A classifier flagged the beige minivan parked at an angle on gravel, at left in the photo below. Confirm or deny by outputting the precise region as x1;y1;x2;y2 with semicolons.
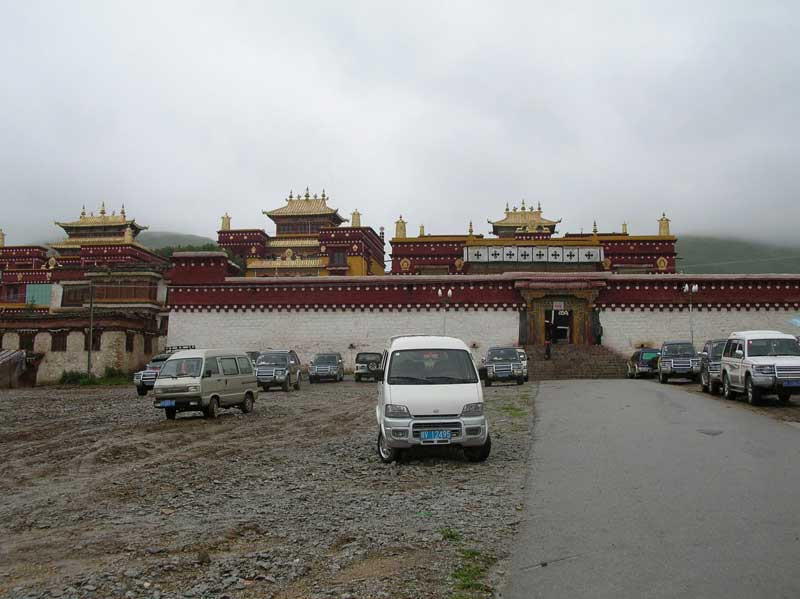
153;349;258;420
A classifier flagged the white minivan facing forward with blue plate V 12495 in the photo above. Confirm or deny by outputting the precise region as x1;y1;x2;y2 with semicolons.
375;335;492;463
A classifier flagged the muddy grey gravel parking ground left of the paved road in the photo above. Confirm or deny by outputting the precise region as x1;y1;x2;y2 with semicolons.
0;382;537;599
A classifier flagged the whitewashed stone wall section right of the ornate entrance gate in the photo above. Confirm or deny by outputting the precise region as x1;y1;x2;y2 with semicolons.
600;310;800;354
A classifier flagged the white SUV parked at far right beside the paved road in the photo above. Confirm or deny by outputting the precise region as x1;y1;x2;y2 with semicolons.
722;331;800;405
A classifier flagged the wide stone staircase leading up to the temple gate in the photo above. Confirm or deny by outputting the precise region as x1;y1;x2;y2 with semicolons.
525;344;627;381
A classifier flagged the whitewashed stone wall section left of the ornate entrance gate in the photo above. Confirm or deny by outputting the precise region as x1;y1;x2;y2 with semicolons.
167;310;519;368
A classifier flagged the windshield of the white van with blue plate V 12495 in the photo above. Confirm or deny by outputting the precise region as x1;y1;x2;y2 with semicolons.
387;349;478;385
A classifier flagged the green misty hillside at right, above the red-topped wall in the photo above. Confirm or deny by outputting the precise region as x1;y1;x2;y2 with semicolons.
677;235;800;274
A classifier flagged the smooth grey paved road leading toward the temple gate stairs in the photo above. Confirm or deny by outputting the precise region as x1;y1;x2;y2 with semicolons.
502;380;800;599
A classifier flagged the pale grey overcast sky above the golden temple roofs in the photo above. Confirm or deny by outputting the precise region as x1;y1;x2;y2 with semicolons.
0;0;800;244
